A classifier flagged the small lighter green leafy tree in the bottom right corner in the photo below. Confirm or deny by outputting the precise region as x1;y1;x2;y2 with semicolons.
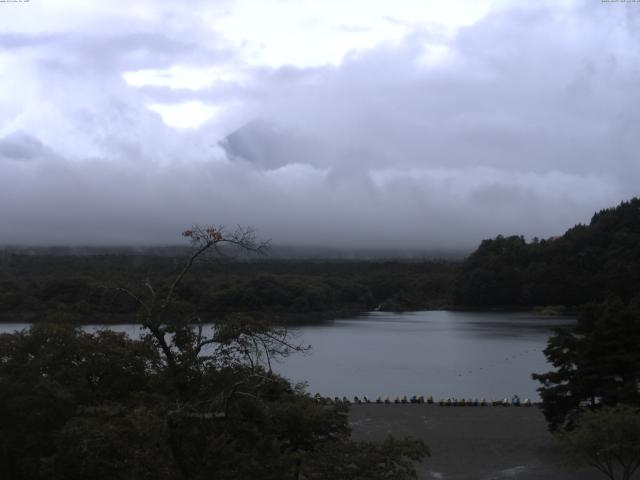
557;406;640;480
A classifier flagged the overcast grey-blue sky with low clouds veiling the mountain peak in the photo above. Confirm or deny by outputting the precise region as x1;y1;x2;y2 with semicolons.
0;0;640;248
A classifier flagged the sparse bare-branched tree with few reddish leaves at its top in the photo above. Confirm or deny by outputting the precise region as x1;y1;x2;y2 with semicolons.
116;225;308;394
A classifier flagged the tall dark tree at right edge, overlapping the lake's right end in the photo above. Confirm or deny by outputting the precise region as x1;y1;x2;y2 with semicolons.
533;297;640;430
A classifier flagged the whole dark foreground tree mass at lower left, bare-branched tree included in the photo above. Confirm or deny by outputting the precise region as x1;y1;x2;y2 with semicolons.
0;228;429;480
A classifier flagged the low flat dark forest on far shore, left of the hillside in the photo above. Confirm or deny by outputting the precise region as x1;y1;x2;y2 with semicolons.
0;252;456;322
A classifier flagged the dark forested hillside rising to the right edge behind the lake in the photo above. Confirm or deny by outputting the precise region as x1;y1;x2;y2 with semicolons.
453;198;640;307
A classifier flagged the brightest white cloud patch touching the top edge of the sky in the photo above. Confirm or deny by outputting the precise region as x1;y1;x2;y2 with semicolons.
212;0;497;67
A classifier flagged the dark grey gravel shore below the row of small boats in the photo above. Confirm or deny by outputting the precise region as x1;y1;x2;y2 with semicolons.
349;404;604;480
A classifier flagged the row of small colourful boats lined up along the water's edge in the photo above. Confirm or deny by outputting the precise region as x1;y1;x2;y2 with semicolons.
314;393;533;407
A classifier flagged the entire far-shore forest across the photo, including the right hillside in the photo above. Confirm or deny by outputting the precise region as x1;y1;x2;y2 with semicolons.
0;198;640;323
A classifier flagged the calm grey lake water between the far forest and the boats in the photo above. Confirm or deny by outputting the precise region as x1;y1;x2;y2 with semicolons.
0;311;571;399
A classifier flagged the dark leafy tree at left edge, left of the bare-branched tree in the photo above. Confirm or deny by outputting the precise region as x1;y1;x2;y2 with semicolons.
0;324;158;480
